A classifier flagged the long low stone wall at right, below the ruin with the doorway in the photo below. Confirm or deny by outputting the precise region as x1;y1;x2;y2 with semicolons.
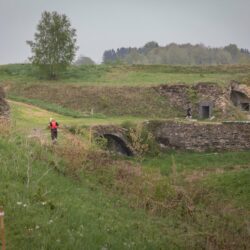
148;121;250;151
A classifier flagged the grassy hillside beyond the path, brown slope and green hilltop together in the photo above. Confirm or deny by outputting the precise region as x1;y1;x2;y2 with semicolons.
0;64;250;119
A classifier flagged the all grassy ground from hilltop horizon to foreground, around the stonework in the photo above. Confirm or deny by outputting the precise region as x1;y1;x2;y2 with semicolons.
0;65;250;250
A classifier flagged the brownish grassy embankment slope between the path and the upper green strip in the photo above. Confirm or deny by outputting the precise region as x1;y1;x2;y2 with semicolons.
7;83;180;118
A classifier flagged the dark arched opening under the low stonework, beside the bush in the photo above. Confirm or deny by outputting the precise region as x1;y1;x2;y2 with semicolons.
103;134;134;156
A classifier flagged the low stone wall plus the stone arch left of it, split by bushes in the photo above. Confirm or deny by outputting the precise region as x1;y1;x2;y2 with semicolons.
92;120;250;156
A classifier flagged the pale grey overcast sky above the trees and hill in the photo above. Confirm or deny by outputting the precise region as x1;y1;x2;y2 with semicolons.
0;0;250;64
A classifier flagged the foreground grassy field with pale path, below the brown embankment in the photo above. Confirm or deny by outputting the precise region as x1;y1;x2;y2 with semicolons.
0;99;250;250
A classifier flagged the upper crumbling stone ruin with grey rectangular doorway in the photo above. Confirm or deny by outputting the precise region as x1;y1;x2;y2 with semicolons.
154;81;250;119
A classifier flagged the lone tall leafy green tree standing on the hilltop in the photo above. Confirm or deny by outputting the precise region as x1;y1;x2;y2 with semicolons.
27;11;77;79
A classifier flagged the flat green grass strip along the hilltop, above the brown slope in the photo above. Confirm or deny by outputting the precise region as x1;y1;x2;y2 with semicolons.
0;64;250;86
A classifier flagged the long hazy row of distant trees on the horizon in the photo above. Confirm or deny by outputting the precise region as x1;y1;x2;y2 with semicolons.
103;41;250;65
